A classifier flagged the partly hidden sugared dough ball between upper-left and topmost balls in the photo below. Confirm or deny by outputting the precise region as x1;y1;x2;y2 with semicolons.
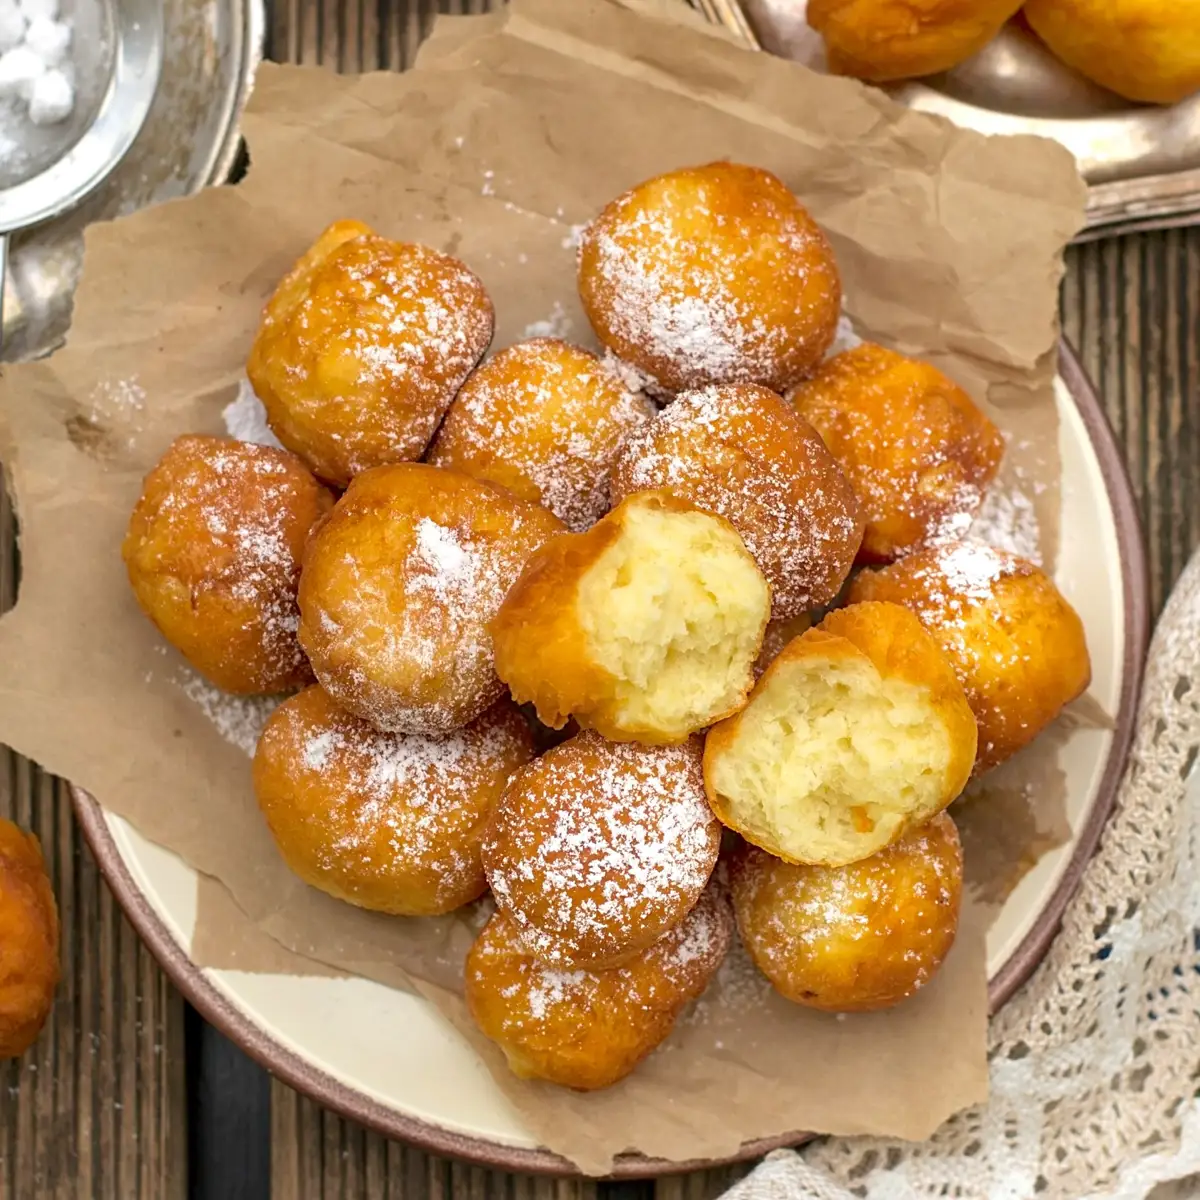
428;337;655;530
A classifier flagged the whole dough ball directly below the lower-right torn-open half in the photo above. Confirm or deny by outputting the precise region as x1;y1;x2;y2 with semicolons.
730;812;962;1013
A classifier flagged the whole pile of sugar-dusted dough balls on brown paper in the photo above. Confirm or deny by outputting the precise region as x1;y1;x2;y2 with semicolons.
124;163;1087;1090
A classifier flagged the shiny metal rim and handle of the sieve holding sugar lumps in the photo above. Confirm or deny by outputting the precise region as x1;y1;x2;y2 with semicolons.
0;0;163;350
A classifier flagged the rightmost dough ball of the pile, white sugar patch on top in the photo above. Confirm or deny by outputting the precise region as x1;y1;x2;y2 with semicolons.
850;540;1092;775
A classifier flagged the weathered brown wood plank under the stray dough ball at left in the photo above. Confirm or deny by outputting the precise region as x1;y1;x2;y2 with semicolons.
0;472;186;1200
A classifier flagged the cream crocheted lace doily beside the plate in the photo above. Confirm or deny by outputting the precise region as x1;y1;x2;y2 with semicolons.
728;554;1200;1200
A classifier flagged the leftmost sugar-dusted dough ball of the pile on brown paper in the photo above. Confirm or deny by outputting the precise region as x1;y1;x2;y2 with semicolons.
121;436;334;695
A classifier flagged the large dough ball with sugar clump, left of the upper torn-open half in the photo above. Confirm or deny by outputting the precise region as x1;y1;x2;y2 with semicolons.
300;463;563;736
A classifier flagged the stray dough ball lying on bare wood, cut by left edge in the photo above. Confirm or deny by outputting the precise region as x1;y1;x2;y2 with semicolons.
0;820;61;1058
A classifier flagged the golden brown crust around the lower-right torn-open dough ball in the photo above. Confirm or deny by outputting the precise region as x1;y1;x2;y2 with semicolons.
704;602;978;865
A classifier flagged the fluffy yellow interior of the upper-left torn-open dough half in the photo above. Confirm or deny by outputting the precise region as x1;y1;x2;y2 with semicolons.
578;506;770;738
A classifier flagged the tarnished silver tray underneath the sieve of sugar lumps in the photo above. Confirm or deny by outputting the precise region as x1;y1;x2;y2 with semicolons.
4;0;264;361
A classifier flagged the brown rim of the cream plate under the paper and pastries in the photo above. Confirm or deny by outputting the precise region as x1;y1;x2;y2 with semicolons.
71;342;1150;1178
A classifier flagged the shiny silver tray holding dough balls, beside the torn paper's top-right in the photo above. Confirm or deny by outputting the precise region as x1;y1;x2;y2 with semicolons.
697;0;1200;238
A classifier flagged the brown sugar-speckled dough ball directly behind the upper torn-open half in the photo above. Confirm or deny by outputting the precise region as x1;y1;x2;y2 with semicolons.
612;384;863;620
